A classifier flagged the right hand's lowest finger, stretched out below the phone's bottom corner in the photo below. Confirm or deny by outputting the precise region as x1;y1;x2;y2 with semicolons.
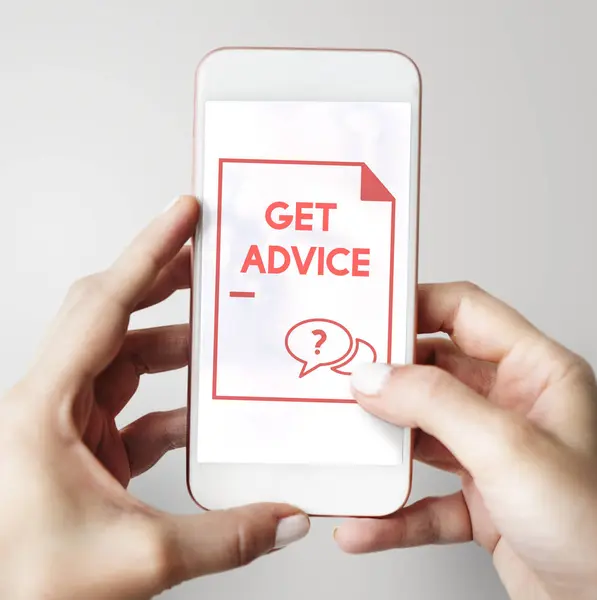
334;492;472;554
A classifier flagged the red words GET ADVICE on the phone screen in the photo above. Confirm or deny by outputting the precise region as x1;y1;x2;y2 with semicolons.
240;202;371;277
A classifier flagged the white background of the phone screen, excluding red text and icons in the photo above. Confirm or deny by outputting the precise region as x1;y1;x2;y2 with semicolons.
198;102;410;465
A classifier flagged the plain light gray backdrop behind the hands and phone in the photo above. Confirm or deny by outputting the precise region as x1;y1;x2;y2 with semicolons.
0;0;597;600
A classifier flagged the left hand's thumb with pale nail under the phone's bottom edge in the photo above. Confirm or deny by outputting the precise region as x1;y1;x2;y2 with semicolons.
151;504;310;589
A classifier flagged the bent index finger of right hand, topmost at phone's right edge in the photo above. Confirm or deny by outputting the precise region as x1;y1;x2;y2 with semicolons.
418;283;543;362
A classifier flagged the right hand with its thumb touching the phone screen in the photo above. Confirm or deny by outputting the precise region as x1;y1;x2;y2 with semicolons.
335;284;597;600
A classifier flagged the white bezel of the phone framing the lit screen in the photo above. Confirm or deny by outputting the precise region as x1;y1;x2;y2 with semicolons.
187;48;421;517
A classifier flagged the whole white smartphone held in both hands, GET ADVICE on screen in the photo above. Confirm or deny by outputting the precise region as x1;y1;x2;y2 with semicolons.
188;48;421;516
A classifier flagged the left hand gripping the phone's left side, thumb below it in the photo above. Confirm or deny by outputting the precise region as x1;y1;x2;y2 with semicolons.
0;197;309;600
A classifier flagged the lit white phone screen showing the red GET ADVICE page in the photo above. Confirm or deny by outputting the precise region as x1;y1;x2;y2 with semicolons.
194;101;412;466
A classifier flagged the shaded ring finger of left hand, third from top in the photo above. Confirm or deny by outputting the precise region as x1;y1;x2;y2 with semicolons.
94;325;189;417
